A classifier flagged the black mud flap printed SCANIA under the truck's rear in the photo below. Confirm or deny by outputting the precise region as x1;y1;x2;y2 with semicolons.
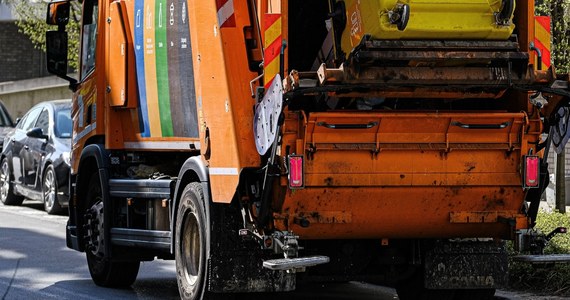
424;241;508;289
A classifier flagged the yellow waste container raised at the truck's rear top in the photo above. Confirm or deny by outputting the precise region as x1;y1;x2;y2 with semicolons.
342;0;515;53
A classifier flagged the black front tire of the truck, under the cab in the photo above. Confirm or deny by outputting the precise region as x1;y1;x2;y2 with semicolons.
85;174;140;287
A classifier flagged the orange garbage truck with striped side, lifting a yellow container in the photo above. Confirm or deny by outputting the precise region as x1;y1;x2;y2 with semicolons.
46;0;570;299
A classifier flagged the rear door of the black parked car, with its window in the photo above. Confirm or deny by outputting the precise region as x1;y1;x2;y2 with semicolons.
8;107;42;185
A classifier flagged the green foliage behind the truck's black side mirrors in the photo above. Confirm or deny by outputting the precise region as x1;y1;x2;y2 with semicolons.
6;0;81;69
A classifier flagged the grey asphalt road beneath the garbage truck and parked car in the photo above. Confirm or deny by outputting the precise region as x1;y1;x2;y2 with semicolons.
0;201;556;300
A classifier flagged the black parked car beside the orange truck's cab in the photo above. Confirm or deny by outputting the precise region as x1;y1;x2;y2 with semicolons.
0;100;72;214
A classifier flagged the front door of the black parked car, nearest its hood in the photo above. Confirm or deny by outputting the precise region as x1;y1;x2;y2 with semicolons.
24;106;51;191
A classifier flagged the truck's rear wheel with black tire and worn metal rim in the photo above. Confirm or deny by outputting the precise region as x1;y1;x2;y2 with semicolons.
175;182;209;300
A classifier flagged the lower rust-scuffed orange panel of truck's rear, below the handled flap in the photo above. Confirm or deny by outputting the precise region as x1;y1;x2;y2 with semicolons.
276;188;528;239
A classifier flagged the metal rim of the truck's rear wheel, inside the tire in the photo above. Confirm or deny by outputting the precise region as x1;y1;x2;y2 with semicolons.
180;213;202;285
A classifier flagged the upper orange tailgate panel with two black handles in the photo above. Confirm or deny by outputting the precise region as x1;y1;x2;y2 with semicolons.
305;112;526;152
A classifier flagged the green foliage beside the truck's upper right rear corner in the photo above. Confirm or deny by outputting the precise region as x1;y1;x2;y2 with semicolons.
536;0;570;73
